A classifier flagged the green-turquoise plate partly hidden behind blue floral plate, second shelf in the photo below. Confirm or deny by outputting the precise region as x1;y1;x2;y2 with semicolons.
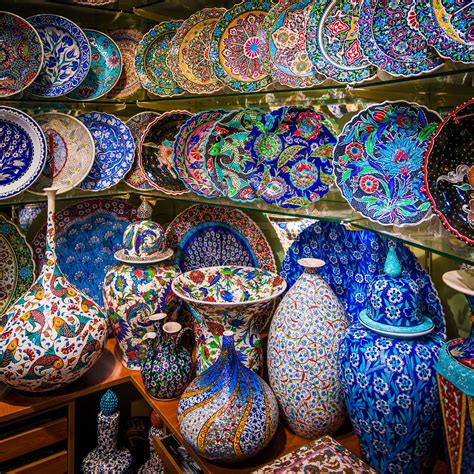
204;108;263;202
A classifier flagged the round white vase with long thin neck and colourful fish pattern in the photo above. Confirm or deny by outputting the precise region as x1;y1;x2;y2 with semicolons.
0;188;107;392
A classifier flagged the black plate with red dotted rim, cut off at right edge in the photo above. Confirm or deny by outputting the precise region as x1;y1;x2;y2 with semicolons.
424;99;474;245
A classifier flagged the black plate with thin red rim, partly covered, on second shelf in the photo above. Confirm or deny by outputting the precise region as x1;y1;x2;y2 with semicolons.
139;110;192;195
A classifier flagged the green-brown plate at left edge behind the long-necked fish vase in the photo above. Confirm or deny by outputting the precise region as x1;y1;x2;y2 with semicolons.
0;214;35;318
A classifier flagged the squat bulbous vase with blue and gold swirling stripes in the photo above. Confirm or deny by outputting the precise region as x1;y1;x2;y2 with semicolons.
178;331;278;462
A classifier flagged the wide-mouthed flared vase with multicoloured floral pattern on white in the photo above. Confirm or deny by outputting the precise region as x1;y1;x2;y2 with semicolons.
172;266;286;374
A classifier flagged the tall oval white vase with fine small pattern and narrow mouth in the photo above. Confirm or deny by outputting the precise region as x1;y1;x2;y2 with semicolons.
268;258;347;438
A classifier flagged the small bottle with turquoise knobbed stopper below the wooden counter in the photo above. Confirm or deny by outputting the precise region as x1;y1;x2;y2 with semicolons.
81;390;132;474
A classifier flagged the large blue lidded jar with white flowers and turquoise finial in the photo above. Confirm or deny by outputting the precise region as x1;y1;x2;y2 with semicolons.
339;247;444;473
